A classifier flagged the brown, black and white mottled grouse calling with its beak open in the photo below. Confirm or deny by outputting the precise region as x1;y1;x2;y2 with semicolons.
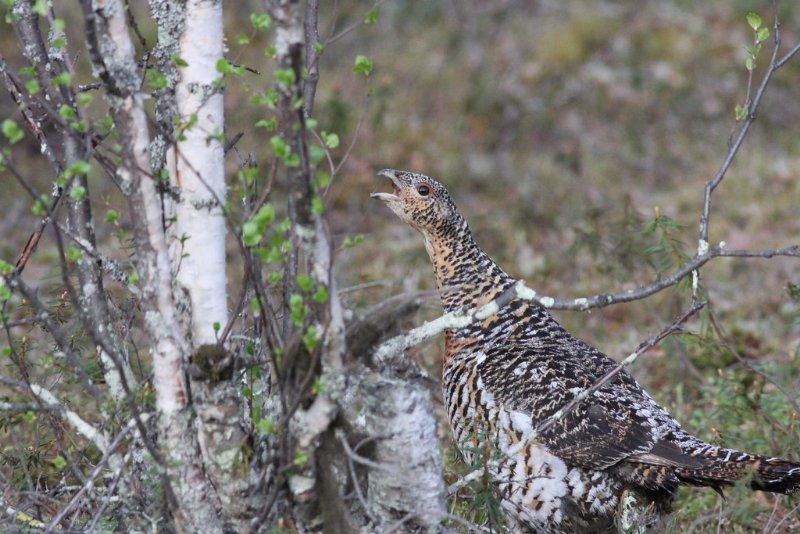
372;169;800;532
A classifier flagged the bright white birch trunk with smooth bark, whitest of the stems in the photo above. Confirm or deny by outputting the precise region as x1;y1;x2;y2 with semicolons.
167;0;228;346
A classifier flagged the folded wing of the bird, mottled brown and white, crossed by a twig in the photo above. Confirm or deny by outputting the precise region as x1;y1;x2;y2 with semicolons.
478;338;659;469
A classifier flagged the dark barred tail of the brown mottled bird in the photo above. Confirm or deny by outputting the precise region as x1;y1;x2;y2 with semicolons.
676;448;800;495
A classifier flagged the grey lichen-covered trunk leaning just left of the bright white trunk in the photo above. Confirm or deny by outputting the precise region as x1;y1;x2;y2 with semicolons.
82;0;222;531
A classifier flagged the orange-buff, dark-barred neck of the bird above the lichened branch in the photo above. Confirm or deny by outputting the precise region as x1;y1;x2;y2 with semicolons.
423;221;515;312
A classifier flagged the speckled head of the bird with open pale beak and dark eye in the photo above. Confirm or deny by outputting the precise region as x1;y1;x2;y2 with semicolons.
370;169;465;236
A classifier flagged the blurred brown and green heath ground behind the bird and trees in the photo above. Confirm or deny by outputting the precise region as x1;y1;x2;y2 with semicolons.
0;0;800;531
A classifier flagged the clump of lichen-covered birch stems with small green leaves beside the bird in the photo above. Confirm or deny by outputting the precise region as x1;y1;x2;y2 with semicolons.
2;0;445;532
